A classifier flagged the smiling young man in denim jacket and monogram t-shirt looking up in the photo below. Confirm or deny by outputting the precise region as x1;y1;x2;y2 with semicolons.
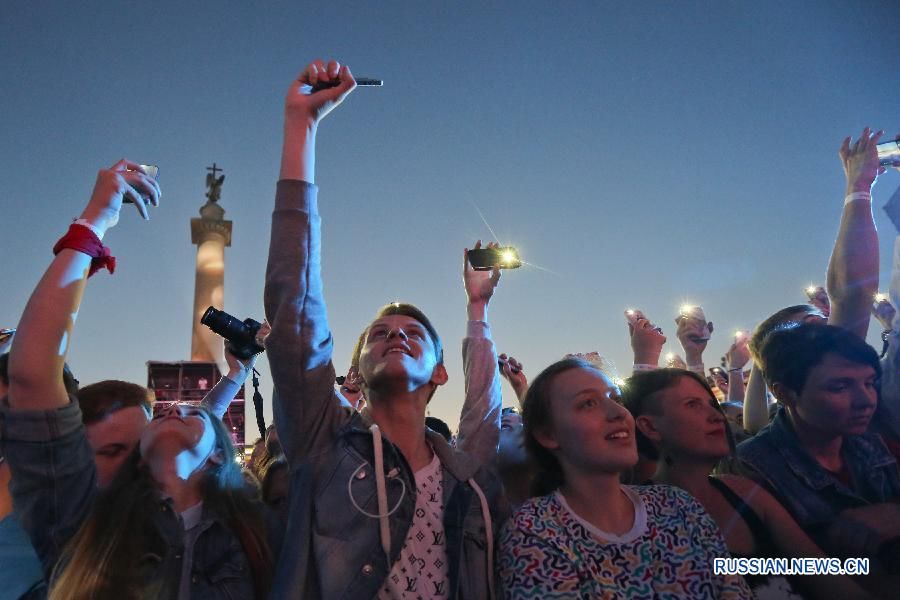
265;61;505;599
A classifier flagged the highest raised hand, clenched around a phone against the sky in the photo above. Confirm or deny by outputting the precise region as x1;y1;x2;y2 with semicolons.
284;60;356;126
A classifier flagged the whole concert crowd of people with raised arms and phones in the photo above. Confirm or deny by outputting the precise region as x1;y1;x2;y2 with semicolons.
0;61;900;600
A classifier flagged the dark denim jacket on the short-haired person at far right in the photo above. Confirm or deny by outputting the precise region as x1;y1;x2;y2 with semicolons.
737;407;900;546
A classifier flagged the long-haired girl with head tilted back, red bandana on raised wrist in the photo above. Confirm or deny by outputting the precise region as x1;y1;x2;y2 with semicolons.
0;160;273;600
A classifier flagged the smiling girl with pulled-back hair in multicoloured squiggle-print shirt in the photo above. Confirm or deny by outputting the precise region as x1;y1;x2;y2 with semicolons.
500;358;752;598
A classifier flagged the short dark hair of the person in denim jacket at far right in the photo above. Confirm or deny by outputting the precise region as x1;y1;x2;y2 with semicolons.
759;324;881;394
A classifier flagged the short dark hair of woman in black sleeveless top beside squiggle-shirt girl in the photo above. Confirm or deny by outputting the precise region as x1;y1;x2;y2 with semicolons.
622;369;722;460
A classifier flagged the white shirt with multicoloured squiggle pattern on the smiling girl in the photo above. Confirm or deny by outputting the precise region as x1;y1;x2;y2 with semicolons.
500;485;753;600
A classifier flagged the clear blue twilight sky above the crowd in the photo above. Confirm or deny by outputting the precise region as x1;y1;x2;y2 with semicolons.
0;0;900;437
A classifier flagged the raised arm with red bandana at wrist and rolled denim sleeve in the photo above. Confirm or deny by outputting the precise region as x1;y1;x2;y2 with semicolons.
0;160;160;578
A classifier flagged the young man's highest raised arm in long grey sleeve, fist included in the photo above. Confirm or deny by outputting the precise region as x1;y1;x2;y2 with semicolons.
265;61;356;466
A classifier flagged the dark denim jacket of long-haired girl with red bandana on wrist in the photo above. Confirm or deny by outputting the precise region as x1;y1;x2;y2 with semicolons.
0;398;268;600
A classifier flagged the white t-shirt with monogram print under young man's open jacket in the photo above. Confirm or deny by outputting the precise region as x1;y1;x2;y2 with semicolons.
378;454;450;600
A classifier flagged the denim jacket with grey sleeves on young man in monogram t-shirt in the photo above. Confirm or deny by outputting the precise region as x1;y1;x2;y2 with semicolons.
265;181;508;600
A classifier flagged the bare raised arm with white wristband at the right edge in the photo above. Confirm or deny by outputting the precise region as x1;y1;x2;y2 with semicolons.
828;127;884;339
